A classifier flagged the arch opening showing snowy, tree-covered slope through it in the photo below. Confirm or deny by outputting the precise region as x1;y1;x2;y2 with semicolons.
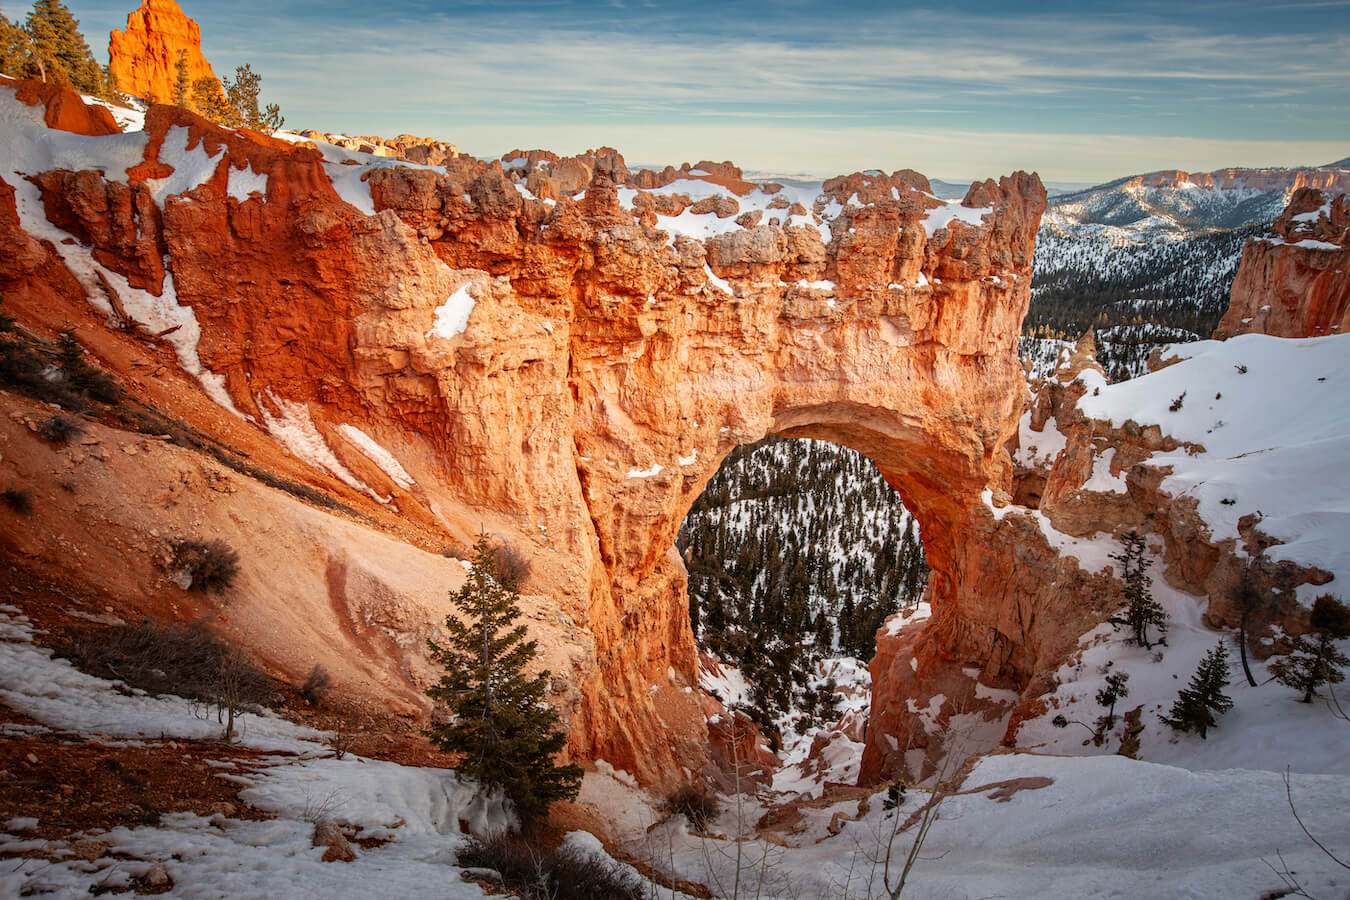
676;434;929;758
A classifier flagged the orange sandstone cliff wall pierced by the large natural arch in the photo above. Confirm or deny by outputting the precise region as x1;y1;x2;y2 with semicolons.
0;84;1047;781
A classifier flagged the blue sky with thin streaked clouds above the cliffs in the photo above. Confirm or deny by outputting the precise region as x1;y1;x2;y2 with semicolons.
10;0;1350;184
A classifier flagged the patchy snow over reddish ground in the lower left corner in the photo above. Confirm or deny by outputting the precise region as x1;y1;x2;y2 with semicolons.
0;606;509;899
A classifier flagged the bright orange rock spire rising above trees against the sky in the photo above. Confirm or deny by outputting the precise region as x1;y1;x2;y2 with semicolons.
108;0;216;103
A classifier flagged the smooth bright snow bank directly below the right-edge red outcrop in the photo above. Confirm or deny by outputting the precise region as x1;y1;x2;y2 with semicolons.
1079;335;1350;603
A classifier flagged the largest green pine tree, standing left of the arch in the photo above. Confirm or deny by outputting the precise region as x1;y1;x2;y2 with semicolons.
425;534;582;826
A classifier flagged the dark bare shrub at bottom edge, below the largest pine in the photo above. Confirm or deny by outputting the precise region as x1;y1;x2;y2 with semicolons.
456;831;651;900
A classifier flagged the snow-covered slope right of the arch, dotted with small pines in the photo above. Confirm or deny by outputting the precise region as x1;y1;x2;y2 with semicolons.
1018;335;1350;776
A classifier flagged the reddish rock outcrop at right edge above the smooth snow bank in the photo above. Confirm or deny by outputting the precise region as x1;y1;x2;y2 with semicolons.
1214;185;1350;340
